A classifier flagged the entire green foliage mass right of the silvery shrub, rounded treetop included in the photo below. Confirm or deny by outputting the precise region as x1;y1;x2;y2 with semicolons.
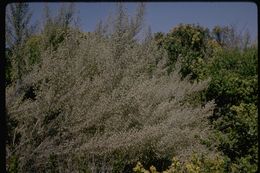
155;25;258;172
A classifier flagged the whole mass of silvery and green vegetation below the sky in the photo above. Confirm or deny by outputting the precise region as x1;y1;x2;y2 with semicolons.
6;3;258;173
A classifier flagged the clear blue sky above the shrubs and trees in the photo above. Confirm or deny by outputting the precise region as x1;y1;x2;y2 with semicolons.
25;2;257;38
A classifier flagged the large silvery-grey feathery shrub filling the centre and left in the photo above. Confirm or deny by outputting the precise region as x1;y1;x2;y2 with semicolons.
7;24;213;172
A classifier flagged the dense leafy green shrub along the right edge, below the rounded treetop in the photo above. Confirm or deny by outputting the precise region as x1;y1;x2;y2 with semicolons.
207;48;258;172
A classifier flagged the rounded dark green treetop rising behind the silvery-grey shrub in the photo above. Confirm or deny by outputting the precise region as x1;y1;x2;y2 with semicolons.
162;24;209;79
